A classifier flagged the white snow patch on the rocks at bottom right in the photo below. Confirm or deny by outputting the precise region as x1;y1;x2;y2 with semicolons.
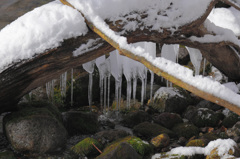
152;139;237;159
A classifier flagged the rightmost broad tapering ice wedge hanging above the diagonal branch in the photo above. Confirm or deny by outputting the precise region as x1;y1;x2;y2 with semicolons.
186;47;202;75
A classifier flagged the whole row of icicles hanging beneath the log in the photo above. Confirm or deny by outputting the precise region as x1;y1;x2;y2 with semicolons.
46;42;206;112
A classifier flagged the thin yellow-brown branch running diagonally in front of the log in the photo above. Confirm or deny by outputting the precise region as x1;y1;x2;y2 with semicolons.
60;0;240;115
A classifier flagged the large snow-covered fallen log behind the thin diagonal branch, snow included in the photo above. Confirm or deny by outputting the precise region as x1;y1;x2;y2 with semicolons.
0;0;240;112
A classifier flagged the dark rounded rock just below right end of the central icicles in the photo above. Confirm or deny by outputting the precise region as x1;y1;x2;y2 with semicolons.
121;111;151;128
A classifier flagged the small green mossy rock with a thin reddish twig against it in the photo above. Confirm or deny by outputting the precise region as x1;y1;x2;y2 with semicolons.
71;137;102;157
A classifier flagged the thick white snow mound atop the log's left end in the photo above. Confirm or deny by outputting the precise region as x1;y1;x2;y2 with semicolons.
0;1;88;72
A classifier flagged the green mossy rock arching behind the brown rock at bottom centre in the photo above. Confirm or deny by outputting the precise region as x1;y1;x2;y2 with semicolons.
99;136;153;156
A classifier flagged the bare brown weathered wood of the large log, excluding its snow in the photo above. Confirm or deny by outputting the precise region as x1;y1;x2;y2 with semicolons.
0;1;240;113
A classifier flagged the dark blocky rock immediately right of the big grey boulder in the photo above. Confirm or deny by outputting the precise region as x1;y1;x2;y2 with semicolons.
63;111;99;135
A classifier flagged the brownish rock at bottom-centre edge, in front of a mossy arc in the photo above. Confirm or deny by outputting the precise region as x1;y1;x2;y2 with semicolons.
96;142;142;159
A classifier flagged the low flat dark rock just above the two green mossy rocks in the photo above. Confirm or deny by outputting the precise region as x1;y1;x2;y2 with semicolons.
95;129;129;144
